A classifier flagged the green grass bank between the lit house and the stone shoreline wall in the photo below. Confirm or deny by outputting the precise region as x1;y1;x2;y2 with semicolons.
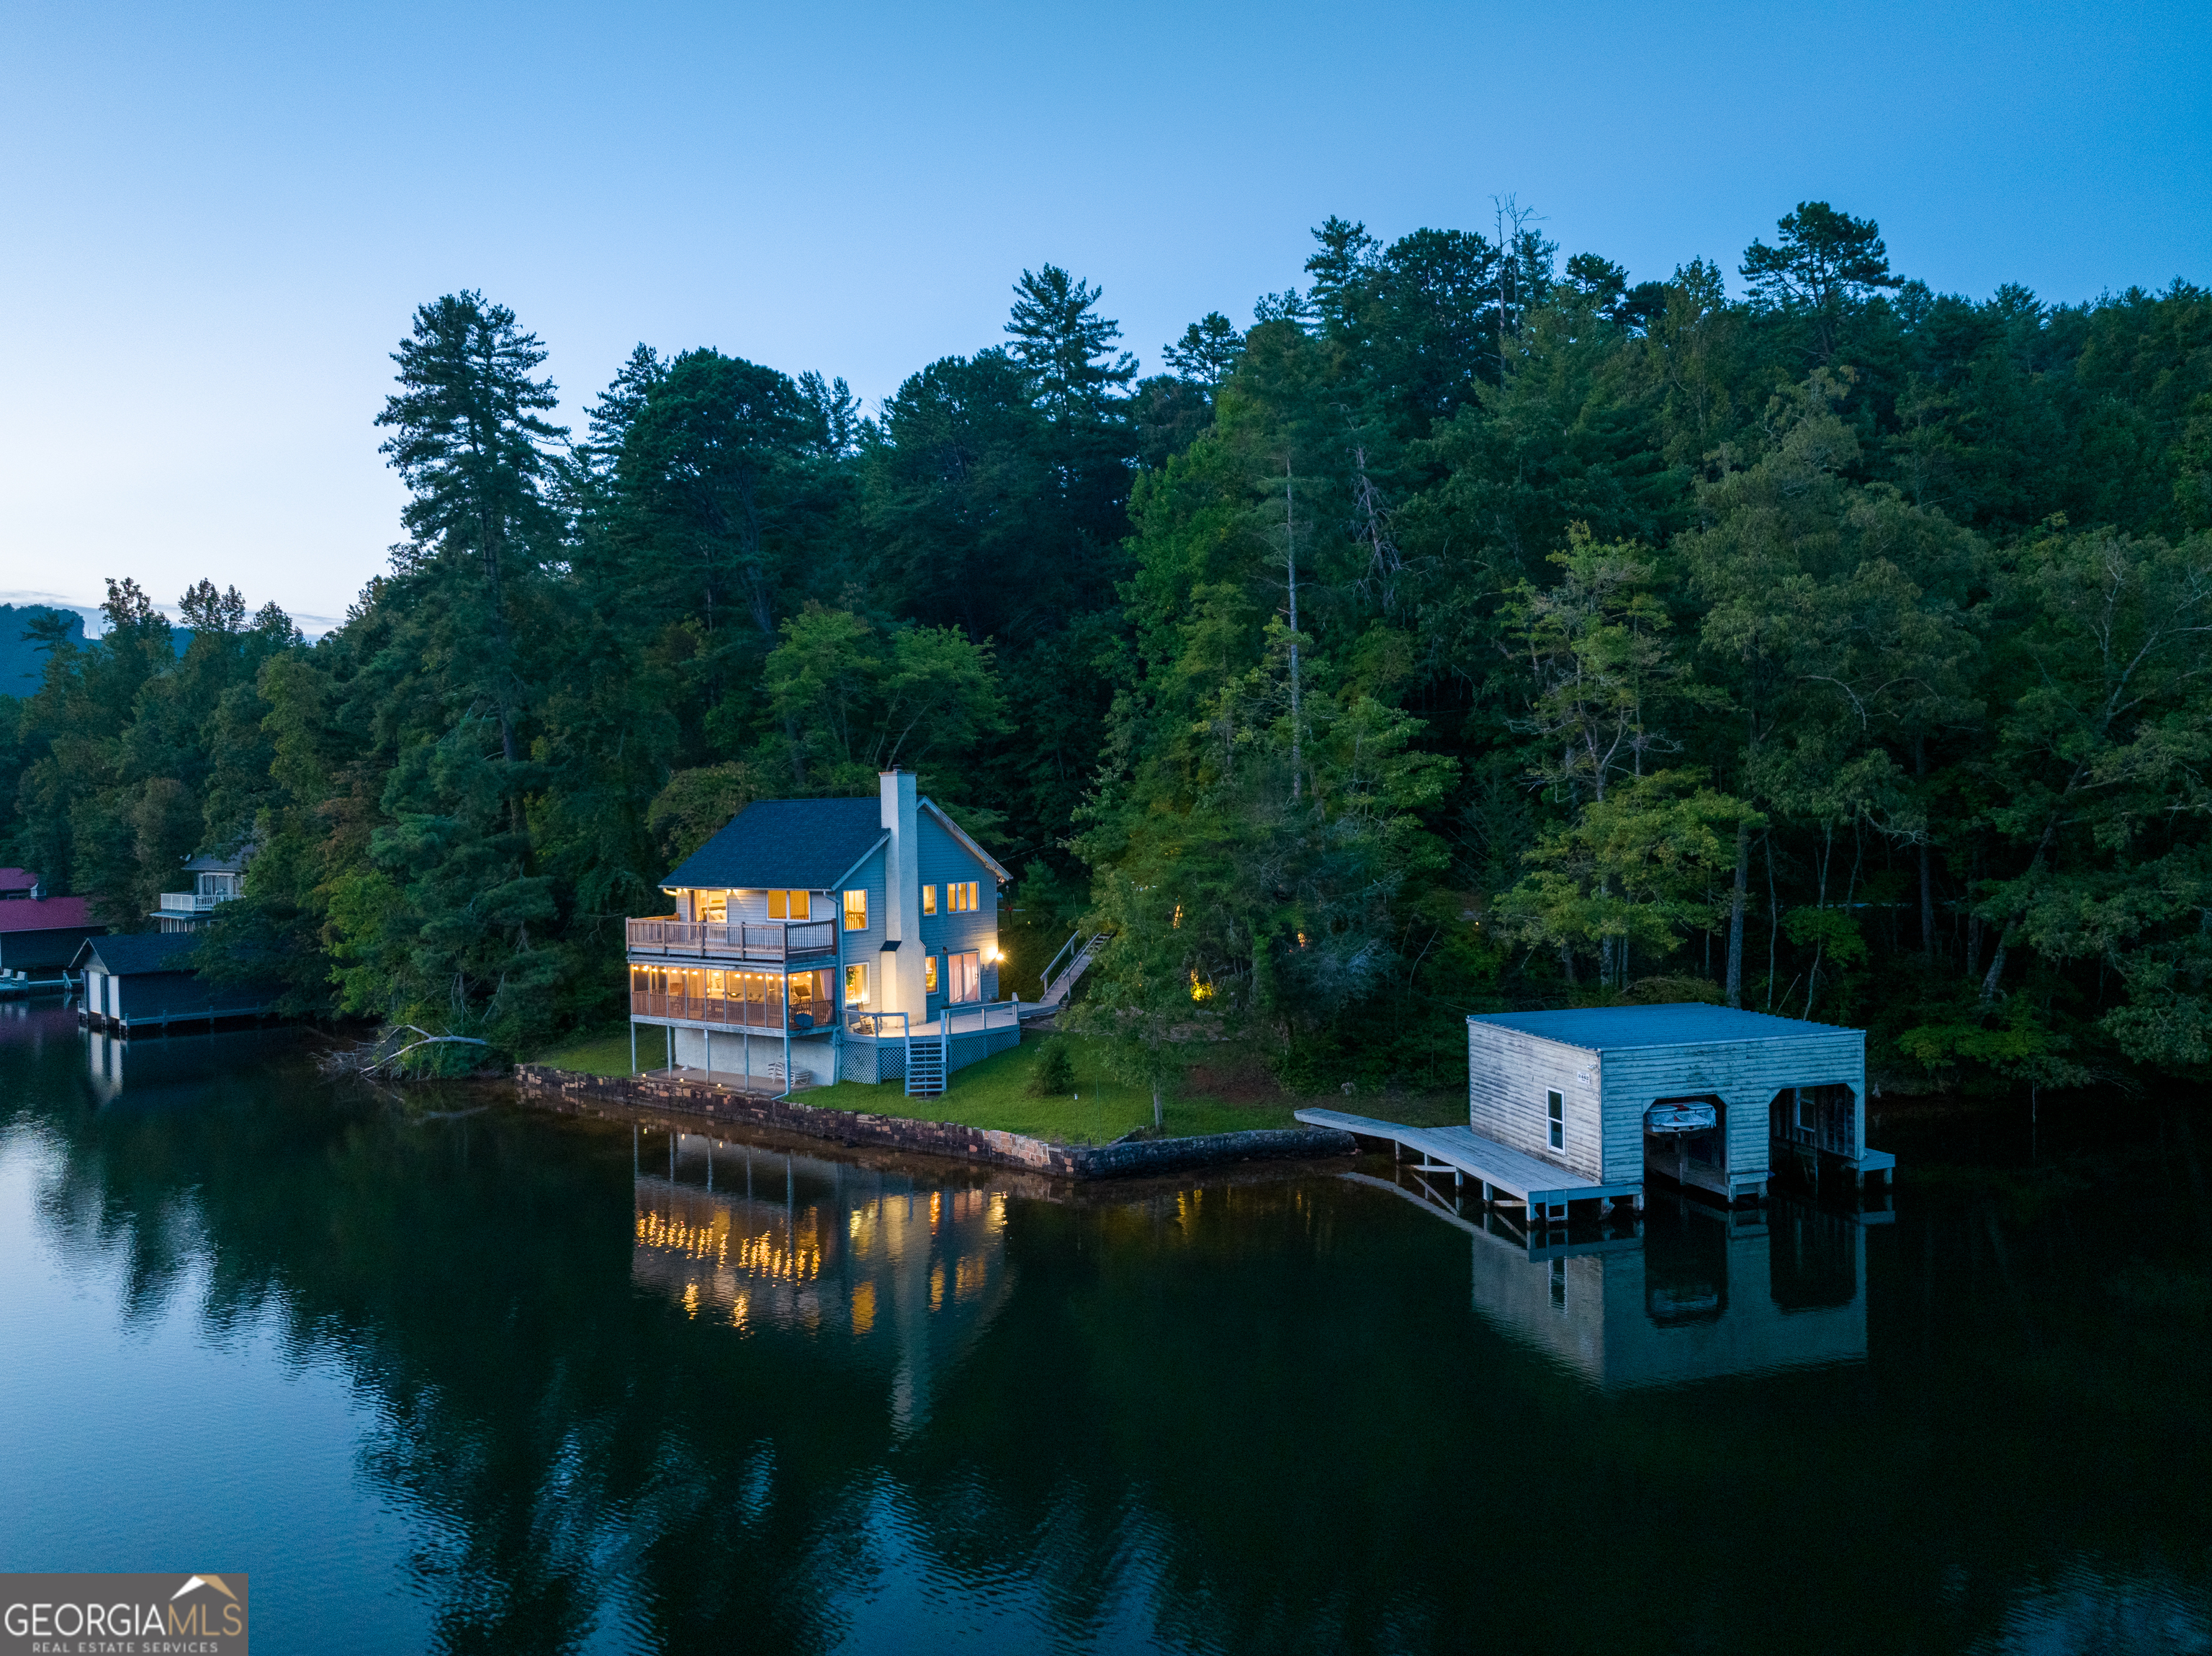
537;1030;1467;1146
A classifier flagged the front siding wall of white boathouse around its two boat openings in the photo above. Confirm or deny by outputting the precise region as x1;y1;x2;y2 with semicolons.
1597;1030;1867;1176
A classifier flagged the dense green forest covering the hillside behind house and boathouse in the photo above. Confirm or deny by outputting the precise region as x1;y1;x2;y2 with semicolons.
0;201;2212;1088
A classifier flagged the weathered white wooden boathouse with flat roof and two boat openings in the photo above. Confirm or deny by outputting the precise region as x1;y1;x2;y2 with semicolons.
1467;1002;1894;1200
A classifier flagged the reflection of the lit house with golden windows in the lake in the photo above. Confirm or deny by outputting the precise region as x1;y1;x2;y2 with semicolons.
631;1128;1011;1431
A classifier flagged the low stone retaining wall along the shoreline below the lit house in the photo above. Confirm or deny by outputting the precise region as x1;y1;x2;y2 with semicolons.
516;1063;1356;1179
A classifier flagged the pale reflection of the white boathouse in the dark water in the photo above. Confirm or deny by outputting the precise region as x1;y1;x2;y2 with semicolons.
1471;1196;1884;1388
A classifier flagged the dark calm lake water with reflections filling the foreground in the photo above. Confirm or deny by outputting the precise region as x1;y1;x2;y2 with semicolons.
0;1002;2212;1656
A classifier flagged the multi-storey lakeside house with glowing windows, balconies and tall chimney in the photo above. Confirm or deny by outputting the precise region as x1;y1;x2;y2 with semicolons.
626;772;1020;1092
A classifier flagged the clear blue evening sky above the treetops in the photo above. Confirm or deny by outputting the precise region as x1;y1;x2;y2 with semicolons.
0;0;2212;617
